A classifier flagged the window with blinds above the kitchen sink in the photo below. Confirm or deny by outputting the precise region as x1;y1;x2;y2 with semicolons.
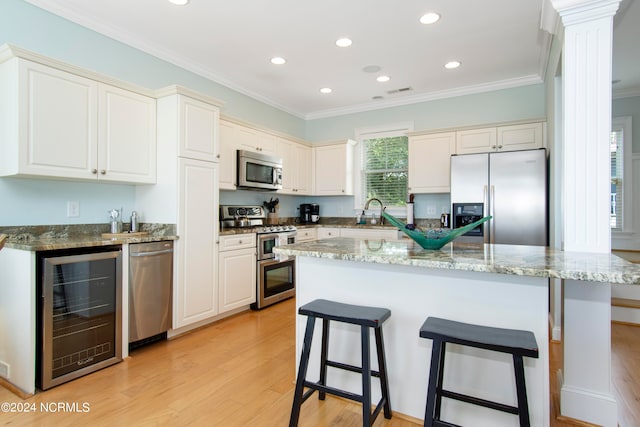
356;126;410;210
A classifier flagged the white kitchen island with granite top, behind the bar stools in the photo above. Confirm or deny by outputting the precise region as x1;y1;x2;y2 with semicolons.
275;238;640;427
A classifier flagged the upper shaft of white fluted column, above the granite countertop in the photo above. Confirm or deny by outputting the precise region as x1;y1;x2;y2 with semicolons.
552;0;620;253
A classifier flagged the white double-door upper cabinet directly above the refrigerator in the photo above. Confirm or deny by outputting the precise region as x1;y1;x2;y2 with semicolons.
456;122;544;154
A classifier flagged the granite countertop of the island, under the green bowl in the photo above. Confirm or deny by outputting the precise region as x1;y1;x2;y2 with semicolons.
274;237;640;285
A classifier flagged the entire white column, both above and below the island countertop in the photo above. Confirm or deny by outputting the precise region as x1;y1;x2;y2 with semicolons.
551;0;620;427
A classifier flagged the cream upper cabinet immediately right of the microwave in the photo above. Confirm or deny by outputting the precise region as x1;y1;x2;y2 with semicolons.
276;138;311;195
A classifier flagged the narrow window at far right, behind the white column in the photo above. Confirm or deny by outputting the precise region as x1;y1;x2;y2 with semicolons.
609;117;631;231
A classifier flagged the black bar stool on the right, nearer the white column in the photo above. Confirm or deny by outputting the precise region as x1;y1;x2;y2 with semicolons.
420;317;538;427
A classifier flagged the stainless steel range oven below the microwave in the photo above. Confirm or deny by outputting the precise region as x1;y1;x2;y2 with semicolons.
252;231;296;309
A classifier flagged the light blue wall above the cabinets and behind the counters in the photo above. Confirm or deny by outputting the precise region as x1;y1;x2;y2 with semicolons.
0;0;544;225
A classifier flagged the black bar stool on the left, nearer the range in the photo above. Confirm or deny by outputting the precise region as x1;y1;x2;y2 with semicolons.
289;299;391;427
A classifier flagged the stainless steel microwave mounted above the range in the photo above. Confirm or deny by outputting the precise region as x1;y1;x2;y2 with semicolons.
237;150;282;190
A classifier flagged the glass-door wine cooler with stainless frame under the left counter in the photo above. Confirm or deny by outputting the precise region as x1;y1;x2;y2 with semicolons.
37;246;122;390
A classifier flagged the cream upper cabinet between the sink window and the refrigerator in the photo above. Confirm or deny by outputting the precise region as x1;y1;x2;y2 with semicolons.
407;132;456;193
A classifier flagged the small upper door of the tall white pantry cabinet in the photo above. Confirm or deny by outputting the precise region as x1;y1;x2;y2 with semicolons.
177;95;220;162
